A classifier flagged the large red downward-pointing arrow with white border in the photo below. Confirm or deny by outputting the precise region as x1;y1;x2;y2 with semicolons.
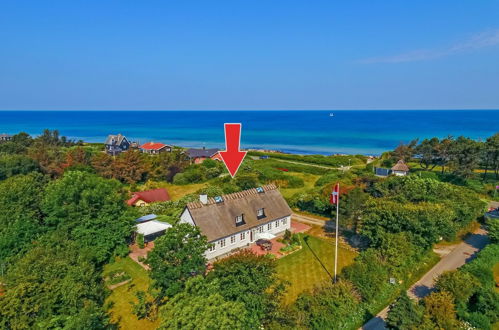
220;124;246;177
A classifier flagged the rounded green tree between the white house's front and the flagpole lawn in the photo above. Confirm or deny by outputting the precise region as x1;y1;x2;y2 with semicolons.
208;250;284;326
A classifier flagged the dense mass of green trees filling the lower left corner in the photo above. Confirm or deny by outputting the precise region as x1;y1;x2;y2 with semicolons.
0;171;135;329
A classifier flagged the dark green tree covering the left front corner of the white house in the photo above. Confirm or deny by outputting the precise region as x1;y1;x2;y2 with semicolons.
146;223;209;301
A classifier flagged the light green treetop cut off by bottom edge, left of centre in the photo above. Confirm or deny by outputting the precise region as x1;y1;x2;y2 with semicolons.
160;276;250;330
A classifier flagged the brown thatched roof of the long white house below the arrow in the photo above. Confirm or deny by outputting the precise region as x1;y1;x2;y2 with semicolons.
187;184;291;241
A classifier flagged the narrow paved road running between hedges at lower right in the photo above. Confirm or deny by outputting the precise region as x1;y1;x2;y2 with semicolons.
361;228;489;330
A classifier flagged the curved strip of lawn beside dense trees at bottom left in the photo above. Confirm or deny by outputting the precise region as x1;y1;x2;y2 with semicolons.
104;257;159;330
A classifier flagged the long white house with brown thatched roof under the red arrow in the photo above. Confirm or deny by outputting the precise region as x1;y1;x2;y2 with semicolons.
180;185;291;260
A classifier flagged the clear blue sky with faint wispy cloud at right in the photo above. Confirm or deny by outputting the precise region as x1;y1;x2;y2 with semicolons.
0;0;499;110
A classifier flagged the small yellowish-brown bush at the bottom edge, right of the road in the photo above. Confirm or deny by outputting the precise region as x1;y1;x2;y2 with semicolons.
423;291;457;329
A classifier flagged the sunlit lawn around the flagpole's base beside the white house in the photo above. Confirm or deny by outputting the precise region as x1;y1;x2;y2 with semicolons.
277;235;357;304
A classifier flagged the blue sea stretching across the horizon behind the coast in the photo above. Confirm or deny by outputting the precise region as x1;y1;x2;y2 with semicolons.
0;110;499;155
